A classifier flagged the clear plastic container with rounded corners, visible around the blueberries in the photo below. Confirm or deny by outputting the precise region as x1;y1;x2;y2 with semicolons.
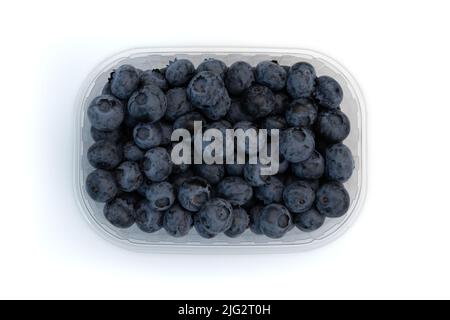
74;48;367;253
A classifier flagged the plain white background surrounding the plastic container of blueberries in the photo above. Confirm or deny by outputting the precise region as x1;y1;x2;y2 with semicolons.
0;0;450;299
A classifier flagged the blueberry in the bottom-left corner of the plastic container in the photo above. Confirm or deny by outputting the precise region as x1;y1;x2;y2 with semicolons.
103;195;135;229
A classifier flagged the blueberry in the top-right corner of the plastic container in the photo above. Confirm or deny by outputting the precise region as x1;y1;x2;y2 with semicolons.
313;76;344;109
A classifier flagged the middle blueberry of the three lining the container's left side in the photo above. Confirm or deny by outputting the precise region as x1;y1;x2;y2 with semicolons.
87;140;122;170
